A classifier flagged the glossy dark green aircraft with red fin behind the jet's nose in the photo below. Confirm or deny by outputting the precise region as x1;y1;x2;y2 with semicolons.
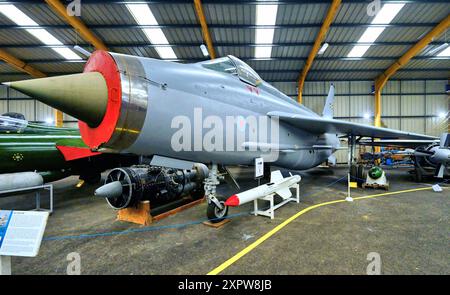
0;113;138;183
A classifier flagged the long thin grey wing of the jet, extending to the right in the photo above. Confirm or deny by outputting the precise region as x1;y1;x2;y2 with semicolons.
267;112;436;140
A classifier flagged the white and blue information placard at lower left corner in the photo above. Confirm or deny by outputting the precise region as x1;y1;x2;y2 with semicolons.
0;210;49;257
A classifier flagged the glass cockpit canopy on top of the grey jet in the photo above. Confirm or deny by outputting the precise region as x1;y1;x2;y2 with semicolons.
200;55;262;86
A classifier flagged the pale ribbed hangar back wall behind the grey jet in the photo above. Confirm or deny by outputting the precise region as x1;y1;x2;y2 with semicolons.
0;80;449;162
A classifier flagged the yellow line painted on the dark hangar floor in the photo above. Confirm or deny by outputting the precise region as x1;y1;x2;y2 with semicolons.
208;187;442;275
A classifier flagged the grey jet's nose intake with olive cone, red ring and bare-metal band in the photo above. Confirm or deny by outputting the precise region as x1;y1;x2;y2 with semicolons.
4;50;149;151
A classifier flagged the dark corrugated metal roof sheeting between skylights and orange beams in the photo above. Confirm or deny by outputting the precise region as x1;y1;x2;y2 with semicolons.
0;1;450;81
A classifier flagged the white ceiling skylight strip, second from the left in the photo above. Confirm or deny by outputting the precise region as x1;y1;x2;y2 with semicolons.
126;4;178;59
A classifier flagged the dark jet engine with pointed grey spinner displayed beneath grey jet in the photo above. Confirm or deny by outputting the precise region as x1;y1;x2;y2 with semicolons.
95;164;209;210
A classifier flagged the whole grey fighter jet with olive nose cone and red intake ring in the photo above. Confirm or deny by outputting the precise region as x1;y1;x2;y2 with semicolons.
2;51;435;221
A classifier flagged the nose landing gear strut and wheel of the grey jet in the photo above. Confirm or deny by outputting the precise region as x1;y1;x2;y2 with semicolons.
204;164;228;223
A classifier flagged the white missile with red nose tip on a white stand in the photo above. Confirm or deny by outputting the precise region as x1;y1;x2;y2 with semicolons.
225;170;302;207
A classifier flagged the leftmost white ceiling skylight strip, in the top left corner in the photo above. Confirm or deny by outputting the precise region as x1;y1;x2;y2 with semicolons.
0;4;81;60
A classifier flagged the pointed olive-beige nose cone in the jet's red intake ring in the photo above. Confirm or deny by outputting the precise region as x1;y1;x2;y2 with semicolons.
3;72;108;127
